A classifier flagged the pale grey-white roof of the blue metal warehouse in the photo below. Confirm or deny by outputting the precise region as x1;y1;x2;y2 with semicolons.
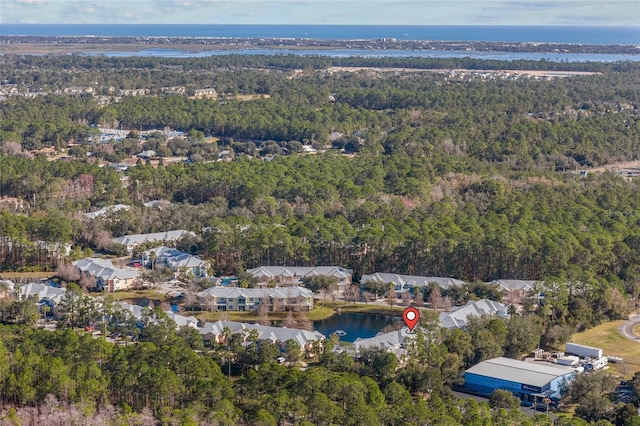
465;357;573;387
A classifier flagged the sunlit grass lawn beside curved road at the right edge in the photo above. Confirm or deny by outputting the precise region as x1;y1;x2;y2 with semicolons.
571;320;640;379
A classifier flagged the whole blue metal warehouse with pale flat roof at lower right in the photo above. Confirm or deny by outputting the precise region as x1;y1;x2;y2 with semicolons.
464;357;575;405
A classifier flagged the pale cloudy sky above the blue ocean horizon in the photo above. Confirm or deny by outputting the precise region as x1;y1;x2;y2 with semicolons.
0;0;640;26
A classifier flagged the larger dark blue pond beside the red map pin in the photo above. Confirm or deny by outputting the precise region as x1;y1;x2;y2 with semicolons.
313;312;402;342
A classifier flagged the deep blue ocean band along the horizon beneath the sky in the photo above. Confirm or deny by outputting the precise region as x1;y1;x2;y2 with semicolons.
0;24;640;45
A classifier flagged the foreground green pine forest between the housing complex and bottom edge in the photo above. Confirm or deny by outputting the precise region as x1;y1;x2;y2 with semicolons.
0;310;640;426
